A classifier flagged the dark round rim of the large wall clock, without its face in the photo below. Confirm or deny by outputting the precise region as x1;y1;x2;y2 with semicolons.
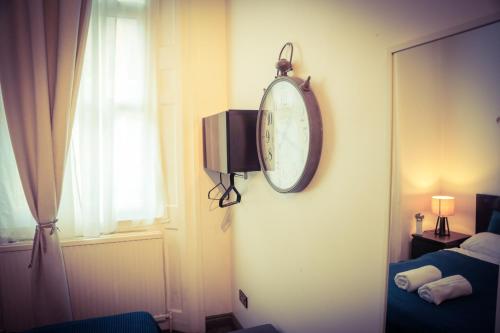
256;76;323;193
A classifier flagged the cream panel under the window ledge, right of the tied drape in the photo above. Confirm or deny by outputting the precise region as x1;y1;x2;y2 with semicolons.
64;239;166;319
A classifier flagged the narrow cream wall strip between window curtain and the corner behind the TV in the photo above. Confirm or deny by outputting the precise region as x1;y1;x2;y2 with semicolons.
158;0;231;332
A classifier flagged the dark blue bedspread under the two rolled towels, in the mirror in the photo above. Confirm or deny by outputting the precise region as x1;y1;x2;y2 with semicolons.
386;250;498;332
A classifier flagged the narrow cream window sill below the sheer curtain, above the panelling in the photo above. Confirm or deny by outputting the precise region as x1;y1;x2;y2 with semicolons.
0;229;163;254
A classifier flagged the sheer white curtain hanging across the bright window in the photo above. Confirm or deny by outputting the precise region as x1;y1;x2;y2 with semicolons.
0;0;166;243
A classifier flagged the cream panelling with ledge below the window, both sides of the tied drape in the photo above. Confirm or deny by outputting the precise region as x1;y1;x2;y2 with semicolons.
0;232;168;331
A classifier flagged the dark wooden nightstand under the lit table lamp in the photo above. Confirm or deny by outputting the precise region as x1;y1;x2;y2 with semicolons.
411;230;470;259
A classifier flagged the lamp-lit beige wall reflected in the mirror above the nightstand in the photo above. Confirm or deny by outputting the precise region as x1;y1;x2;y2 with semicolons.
390;23;500;261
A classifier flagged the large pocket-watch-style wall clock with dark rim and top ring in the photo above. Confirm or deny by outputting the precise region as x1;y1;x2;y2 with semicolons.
257;43;323;193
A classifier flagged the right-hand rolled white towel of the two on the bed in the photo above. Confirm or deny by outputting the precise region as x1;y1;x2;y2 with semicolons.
418;275;472;305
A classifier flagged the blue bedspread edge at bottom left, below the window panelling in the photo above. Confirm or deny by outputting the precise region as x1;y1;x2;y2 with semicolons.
26;312;160;333
